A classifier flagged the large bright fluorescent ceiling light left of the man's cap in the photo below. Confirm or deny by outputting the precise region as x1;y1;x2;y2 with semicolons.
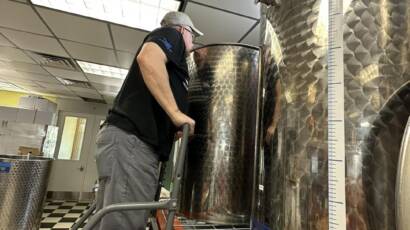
31;0;181;31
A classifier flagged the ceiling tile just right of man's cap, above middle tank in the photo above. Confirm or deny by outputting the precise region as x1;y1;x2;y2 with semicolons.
185;3;256;44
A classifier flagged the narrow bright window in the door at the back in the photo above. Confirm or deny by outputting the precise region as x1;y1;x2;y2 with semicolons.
58;116;87;160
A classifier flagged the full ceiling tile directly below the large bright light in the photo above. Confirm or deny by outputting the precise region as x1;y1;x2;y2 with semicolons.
36;7;113;49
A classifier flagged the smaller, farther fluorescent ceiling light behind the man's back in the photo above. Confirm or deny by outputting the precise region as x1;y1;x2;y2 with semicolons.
77;61;128;79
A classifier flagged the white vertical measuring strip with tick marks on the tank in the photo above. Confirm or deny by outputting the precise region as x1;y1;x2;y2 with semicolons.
324;0;346;230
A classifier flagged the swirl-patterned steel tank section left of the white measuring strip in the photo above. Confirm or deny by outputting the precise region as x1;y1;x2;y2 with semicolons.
253;0;328;230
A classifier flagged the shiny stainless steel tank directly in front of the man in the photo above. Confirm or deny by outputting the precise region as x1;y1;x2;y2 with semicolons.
180;44;261;223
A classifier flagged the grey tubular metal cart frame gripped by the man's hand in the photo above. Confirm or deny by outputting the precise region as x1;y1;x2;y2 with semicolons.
71;124;189;230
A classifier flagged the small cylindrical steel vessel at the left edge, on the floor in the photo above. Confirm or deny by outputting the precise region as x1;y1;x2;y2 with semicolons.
0;155;51;230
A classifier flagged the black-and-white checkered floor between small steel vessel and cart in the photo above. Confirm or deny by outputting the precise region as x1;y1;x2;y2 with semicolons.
40;201;91;230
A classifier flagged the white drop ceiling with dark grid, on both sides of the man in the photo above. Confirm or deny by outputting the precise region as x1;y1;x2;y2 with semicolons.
0;0;260;103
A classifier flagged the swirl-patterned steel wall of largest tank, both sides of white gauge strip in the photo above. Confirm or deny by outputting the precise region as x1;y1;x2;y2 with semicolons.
255;0;410;230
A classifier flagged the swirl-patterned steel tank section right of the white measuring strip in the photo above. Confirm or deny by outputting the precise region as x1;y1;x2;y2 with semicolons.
343;0;410;227
